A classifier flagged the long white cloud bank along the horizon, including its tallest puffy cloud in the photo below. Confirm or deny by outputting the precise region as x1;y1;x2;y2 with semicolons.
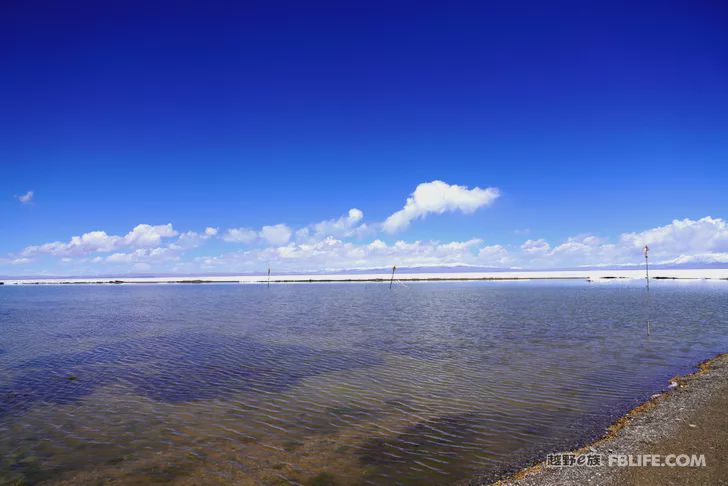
0;180;728;275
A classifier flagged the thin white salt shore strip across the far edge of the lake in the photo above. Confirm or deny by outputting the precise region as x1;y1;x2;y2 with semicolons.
3;269;728;285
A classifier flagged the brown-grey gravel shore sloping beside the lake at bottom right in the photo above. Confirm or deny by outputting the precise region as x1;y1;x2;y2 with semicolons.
469;354;728;486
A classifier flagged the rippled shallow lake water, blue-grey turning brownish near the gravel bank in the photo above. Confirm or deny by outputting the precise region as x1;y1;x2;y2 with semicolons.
0;281;728;484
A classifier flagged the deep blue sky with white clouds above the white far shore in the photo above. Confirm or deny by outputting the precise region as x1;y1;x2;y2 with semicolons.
0;1;728;275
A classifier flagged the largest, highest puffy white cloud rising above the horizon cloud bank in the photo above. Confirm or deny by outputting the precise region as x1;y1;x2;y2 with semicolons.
382;181;500;233
